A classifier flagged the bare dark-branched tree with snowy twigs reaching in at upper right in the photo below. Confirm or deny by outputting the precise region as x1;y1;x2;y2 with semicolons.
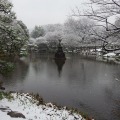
72;0;120;51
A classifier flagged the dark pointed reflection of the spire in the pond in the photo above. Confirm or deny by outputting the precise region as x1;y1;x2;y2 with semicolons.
55;59;65;76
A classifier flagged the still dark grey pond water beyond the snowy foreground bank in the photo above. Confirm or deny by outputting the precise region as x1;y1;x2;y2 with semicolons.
3;55;120;120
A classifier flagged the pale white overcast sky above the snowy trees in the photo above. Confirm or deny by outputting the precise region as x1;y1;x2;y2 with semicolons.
11;0;86;29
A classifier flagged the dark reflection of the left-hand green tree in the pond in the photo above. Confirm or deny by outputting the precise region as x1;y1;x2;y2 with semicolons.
2;60;29;90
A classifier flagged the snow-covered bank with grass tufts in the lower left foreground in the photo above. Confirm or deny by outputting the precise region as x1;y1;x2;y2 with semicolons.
0;93;93;120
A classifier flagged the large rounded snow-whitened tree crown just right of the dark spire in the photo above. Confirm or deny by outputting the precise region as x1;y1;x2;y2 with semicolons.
64;18;95;43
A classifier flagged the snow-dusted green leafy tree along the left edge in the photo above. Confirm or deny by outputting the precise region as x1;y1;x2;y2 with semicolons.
0;0;29;55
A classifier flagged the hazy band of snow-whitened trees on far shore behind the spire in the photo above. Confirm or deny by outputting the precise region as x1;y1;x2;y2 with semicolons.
31;17;95;49
